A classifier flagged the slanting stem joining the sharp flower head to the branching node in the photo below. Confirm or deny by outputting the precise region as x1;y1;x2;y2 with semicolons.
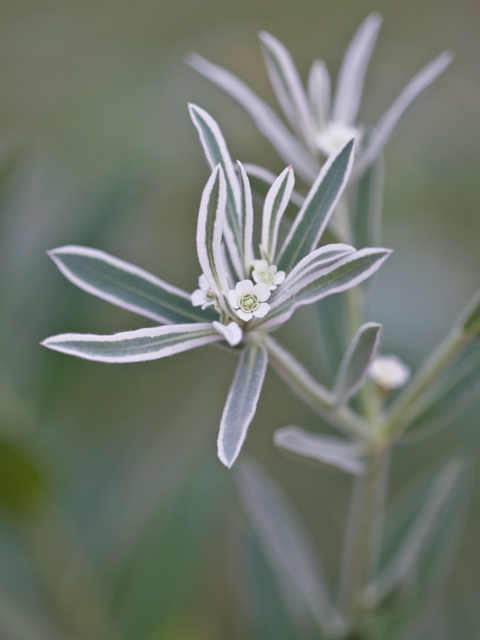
264;336;370;441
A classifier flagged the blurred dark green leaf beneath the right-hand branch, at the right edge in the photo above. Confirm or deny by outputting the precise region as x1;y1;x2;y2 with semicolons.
405;344;480;439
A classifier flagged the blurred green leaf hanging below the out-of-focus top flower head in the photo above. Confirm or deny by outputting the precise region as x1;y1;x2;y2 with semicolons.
353;154;385;249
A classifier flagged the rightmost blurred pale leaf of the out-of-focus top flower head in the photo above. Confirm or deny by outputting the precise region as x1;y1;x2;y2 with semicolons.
354;51;453;177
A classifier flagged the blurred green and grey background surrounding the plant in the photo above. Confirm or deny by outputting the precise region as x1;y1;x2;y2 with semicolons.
0;0;480;640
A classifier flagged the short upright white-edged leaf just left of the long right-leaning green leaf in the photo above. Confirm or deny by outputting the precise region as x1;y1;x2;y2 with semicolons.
262;166;295;263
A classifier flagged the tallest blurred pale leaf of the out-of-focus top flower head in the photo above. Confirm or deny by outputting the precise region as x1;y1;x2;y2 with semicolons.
332;13;382;125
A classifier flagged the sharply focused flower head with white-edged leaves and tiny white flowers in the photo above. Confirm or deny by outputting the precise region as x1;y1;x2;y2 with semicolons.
43;105;390;467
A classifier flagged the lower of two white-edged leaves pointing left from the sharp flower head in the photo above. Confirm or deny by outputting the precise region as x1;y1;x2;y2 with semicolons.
41;322;222;363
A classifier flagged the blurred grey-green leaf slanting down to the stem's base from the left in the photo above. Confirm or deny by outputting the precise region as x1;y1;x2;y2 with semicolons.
235;460;341;630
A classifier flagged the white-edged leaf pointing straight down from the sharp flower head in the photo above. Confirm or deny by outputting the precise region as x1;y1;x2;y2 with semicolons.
217;344;268;469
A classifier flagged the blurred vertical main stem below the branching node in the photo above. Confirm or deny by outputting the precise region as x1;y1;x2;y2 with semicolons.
340;450;390;628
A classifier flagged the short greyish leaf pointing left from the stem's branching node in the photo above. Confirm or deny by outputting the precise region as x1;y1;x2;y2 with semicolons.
273;427;366;475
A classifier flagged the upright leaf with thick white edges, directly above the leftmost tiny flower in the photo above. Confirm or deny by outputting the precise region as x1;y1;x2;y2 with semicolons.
197;164;229;292
